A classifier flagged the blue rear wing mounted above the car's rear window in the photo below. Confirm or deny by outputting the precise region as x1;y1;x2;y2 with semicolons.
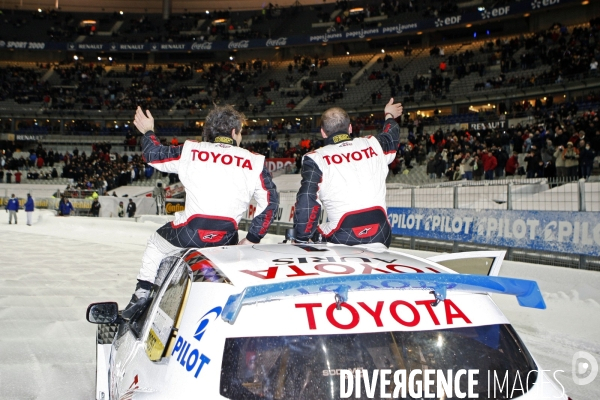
221;273;546;324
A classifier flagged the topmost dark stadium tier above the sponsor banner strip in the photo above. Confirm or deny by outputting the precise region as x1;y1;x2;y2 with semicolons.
0;0;460;43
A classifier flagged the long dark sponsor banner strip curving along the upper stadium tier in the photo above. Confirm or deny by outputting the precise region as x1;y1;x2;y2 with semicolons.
0;0;579;53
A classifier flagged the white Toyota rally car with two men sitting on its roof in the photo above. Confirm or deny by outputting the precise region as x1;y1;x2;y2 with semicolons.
87;244;568;400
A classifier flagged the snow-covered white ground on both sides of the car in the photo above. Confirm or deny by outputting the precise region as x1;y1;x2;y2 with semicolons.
0;211;600;400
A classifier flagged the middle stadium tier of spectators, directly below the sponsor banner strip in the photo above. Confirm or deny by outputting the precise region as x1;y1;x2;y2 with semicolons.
0;19;598;118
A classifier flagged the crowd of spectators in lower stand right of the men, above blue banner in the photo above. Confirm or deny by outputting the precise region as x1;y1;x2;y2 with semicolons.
390;94;600;181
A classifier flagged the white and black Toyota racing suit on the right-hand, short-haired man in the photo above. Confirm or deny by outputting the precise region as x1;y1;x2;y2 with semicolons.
294;118;400;247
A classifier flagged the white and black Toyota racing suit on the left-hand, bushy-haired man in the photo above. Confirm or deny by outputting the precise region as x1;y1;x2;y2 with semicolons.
138;131;279;283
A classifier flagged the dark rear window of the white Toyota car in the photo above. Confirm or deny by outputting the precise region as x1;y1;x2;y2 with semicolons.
220;324;537;400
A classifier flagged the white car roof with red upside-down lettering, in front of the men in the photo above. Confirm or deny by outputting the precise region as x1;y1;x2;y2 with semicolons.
186;244;456;288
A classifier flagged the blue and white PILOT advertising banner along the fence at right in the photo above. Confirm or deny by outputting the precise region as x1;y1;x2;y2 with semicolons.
388;207;600;256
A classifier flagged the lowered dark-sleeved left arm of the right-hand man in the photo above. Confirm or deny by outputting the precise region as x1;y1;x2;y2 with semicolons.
294;156;323;242
